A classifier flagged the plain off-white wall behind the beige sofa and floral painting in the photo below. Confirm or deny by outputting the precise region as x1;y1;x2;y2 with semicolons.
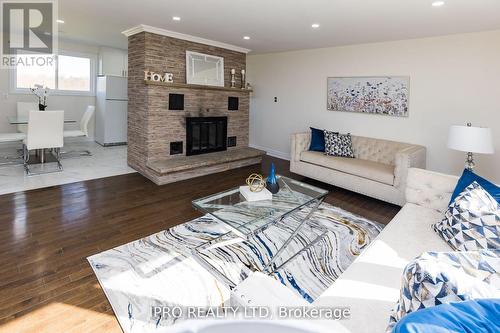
247;31;500;183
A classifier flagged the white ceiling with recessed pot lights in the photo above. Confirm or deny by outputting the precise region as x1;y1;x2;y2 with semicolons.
59;0;500;53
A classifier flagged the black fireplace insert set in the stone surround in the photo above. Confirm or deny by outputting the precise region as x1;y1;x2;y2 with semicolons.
186;117;227;156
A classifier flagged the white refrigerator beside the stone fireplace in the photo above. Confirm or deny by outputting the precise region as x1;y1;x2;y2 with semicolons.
95;76;128;146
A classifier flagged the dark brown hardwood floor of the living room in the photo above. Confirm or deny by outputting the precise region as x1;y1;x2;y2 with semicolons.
0;158;399;333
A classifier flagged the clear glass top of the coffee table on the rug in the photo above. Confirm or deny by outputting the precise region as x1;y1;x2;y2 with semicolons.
193;176;328;235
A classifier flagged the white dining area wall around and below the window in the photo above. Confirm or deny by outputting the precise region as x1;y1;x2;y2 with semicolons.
0;41;99;137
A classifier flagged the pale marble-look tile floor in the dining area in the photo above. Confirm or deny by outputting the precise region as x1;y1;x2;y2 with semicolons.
0;141;136;194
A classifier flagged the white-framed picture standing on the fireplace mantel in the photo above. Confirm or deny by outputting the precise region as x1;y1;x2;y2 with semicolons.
186;51;224;87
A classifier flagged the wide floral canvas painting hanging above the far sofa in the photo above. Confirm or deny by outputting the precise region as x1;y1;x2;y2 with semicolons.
327;76;410;117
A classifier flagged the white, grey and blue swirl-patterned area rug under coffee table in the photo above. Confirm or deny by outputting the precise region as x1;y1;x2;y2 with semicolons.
88;204;383;333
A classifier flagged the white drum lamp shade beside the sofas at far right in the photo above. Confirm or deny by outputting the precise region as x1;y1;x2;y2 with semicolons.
448;126;495;154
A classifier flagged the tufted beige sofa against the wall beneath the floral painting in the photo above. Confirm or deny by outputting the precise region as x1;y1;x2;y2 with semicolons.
290;133;426;206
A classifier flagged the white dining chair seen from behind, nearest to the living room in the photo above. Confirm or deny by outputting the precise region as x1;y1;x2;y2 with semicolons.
23;111;64;175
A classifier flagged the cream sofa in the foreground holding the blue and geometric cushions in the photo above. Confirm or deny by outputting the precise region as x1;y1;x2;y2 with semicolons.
233;168;458;333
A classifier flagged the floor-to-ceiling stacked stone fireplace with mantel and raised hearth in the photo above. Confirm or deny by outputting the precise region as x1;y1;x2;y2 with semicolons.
128;28;264;184
